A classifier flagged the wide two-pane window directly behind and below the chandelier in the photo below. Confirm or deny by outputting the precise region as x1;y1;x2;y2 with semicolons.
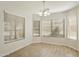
42;14;65;37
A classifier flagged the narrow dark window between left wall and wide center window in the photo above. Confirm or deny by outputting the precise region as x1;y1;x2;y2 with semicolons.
33;14;40;37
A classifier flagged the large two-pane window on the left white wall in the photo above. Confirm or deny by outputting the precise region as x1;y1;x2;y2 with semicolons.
4;12;25;42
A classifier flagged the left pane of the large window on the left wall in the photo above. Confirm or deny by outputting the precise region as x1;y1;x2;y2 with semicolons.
4;13;15;41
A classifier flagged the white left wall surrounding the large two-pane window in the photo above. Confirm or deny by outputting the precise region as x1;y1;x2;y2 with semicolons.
0;3;32;56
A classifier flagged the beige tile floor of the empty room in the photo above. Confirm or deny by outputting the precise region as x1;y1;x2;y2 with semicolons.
6;43;79;57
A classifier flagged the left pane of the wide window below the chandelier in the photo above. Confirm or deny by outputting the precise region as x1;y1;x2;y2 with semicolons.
42;20;51;36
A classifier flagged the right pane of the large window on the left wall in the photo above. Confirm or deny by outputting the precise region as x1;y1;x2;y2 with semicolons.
16;17;25;39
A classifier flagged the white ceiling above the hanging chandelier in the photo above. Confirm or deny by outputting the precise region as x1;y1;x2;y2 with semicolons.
0;1;79;12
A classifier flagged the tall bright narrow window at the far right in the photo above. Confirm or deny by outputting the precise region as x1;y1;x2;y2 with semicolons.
67;9;77;40
